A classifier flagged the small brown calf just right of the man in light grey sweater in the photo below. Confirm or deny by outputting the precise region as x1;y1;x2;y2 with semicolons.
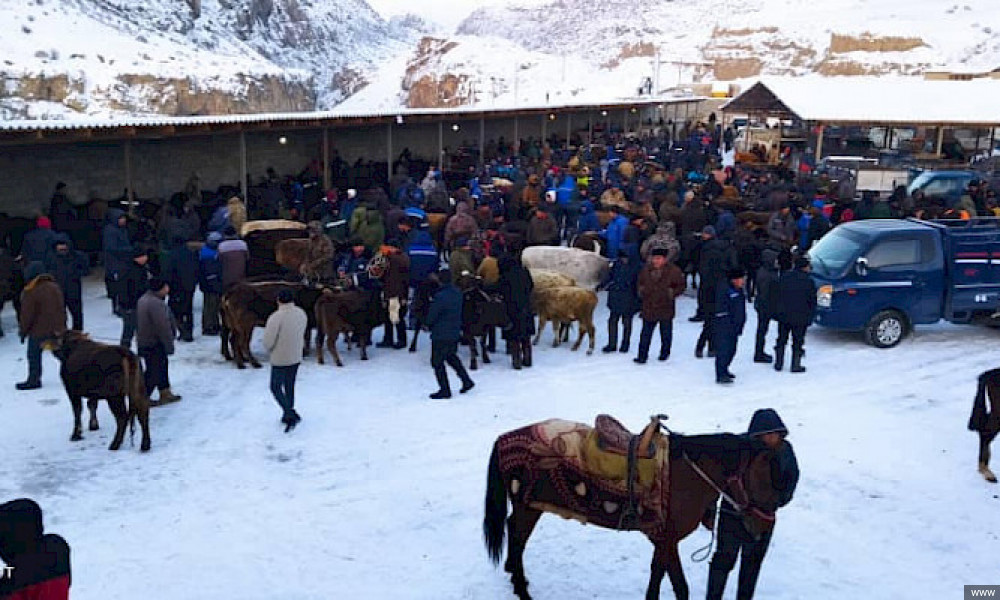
313;288;383;367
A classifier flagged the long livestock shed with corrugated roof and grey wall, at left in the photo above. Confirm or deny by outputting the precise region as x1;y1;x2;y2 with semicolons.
0;96;704;217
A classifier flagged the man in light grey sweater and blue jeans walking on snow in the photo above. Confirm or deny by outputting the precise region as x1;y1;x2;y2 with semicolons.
261;288;308;433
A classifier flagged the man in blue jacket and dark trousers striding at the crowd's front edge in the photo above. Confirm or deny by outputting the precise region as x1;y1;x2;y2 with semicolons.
424;270;476;400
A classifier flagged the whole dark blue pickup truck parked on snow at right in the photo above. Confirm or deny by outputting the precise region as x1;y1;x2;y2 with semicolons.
809;218;1000;348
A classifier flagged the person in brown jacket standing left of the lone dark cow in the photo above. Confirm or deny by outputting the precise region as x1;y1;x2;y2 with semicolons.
15;261;66;390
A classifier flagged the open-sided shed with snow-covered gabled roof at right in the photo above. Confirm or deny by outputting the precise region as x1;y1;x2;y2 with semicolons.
722;77;1000;163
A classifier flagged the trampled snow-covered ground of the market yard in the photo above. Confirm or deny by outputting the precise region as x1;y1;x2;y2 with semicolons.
0;278;1000;600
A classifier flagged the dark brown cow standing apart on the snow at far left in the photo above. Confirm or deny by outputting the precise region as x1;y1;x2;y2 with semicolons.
52;330;150;452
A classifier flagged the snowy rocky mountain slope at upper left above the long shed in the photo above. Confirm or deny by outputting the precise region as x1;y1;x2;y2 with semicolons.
0;0;421;116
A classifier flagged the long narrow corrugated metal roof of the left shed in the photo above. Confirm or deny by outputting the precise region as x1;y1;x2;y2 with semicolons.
0;96;705;131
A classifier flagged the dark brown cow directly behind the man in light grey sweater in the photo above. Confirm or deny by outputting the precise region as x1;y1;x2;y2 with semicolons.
219;280;322;369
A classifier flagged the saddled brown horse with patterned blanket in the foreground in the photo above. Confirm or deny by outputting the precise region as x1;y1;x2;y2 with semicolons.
483;417;778;600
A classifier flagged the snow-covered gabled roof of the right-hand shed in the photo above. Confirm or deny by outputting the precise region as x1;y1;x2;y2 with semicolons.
723;77;1000;126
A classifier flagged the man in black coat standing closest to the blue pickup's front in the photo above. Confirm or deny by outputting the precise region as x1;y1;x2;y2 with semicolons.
774;256;816;373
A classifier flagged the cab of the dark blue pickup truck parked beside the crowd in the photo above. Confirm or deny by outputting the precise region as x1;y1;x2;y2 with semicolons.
809;219;945;348
